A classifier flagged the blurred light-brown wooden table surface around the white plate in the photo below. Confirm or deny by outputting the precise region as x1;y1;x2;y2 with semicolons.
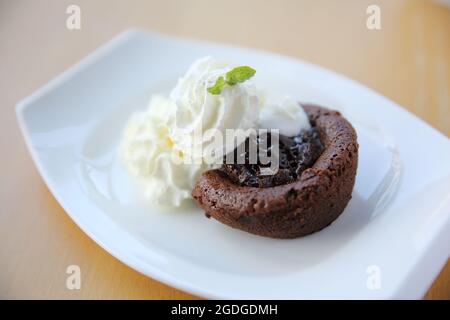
0;0;450;299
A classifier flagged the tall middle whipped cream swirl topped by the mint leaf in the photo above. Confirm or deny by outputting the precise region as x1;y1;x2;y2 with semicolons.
170;57;260;160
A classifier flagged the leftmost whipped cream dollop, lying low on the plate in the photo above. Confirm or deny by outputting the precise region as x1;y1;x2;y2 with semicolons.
121;96;206;207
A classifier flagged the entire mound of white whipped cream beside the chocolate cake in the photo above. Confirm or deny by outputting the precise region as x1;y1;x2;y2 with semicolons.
120;57;310;207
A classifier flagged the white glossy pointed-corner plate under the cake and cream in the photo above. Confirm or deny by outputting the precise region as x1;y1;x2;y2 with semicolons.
17;30;450;299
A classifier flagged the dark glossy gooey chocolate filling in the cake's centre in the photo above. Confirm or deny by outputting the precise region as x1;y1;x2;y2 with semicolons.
220;127;324;188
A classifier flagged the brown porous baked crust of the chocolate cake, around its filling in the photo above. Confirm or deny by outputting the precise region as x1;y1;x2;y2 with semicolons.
192;104;358;238
